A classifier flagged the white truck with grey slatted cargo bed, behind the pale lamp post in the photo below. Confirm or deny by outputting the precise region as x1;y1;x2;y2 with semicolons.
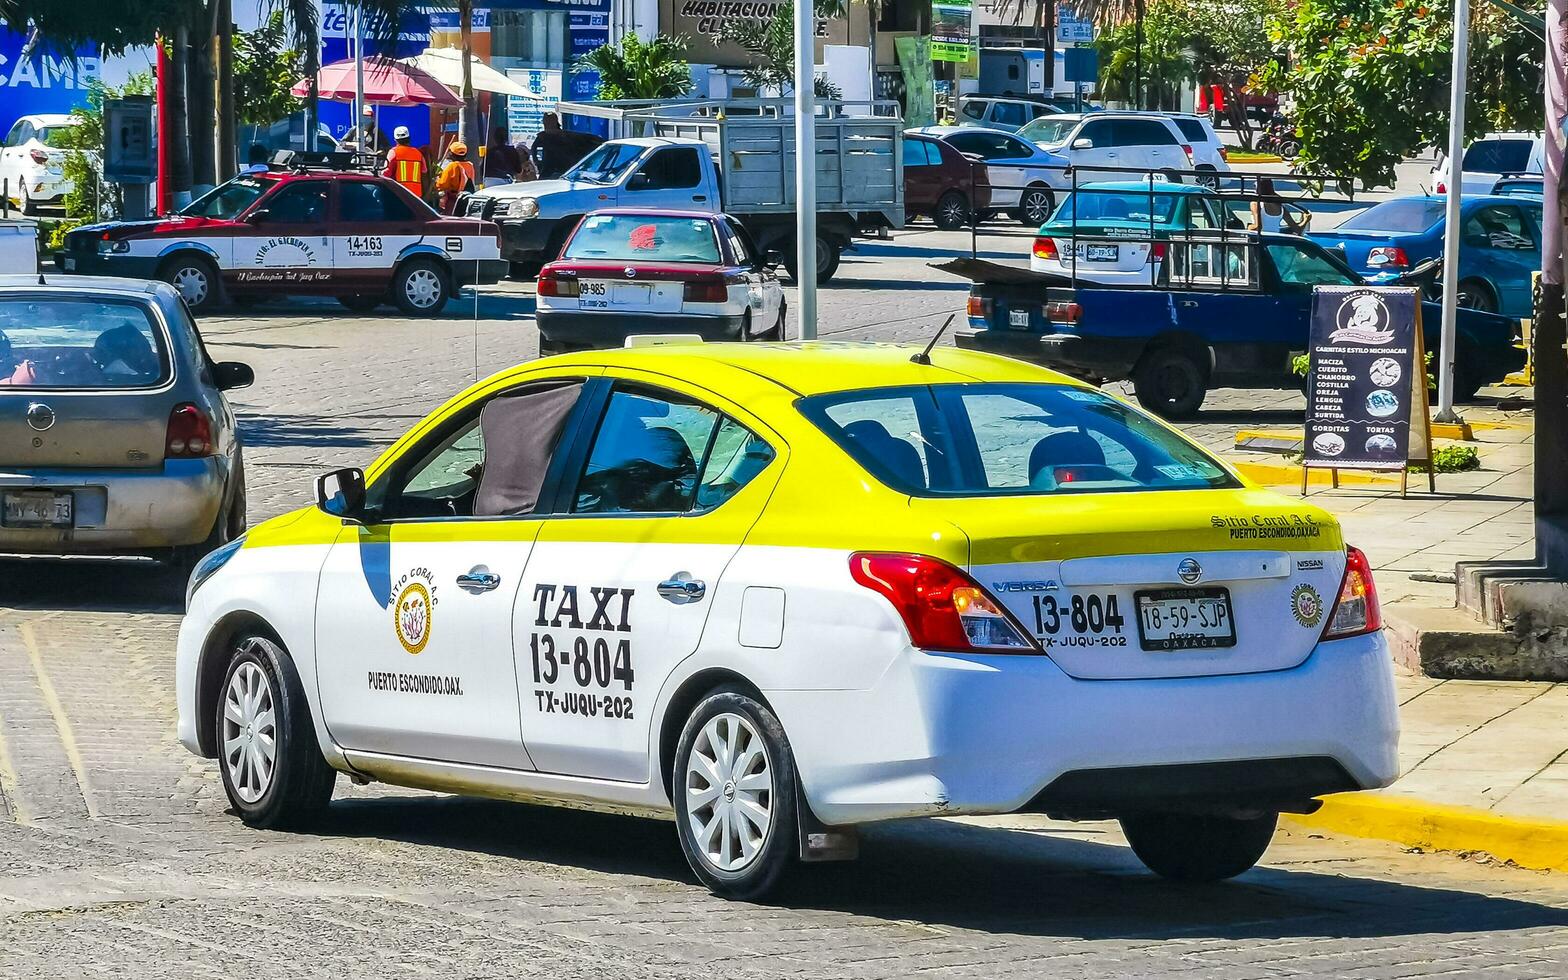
466;108;903;282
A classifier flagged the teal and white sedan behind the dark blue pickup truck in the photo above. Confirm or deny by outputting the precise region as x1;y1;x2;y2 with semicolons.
1029;180;1242;285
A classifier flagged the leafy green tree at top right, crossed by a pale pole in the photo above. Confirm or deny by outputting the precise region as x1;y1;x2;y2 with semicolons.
1259;0;1544;191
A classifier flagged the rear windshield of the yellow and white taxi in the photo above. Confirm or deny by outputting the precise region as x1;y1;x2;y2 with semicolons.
798;384;1239;497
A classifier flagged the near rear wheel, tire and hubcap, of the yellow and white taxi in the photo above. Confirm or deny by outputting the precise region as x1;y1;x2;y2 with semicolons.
671;687;797;898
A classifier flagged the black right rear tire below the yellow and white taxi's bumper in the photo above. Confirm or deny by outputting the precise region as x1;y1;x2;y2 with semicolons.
1121;814;1279;881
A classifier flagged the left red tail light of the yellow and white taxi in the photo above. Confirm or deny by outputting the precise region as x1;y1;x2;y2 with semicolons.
850;552;1040;654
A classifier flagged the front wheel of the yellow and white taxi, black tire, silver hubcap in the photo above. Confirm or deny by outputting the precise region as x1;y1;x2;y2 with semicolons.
215;633;337;828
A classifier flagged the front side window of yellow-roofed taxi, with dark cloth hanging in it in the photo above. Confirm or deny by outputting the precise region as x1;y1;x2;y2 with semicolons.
372;381;582;521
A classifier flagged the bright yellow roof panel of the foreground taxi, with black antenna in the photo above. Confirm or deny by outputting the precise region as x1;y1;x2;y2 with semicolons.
539;340;1076;395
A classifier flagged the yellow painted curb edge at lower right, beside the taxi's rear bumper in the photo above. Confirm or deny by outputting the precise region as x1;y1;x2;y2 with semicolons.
1284;793;1568;872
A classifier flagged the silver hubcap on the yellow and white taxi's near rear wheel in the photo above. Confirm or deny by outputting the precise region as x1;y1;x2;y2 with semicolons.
685;713;773;872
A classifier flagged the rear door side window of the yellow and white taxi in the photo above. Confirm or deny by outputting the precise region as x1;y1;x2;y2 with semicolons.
572;389;775;514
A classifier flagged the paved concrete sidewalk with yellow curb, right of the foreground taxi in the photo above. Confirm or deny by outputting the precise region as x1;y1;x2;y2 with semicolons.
1187;389;1568;870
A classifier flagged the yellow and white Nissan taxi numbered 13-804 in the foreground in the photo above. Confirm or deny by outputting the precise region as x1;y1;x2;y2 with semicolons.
177;343;1397;897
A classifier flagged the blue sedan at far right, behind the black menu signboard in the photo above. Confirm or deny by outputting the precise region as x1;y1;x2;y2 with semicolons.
1311;194;1541;317
